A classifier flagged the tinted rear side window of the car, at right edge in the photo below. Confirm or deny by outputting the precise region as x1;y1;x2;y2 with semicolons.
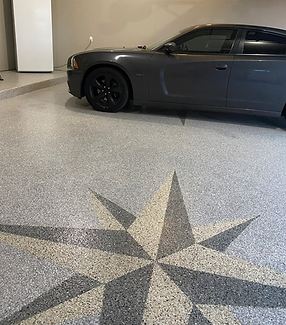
243;30;286;54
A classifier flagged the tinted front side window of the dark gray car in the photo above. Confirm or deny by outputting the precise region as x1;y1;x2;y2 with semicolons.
177;29;237;53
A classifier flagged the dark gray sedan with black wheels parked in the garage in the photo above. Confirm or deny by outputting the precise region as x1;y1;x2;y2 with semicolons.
67;24;286;116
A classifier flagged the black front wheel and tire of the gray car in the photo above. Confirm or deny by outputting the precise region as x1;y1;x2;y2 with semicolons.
85;68;129;113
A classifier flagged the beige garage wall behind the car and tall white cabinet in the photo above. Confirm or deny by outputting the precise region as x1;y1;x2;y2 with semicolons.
0;0;286;70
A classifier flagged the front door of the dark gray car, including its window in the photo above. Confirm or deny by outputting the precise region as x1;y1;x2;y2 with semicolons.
149;28;238;107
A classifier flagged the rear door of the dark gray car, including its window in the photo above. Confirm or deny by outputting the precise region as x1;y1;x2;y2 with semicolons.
227;28;286;115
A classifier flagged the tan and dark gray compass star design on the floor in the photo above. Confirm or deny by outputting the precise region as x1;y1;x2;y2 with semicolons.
0;172;286;325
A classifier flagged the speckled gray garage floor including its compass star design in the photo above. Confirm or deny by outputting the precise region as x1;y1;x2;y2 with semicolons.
0;84;286;325
